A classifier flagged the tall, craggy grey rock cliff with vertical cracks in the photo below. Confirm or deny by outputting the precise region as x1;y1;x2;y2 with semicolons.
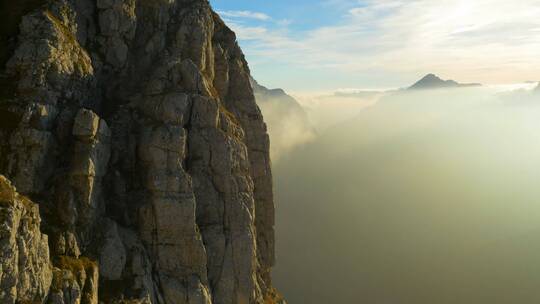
0;0;281;304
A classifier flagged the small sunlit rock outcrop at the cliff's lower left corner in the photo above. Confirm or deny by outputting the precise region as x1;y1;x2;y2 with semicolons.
0;175;52;304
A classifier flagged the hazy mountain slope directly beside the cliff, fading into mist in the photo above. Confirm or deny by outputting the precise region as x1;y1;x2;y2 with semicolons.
250;78;315;160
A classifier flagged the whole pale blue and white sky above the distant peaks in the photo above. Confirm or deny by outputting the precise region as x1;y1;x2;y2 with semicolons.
210;0;540;92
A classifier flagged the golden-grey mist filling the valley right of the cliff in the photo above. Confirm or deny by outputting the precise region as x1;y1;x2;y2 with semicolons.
263;87;540;304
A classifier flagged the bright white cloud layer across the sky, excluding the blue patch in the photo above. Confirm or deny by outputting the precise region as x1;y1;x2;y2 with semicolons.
221;0;540;85
